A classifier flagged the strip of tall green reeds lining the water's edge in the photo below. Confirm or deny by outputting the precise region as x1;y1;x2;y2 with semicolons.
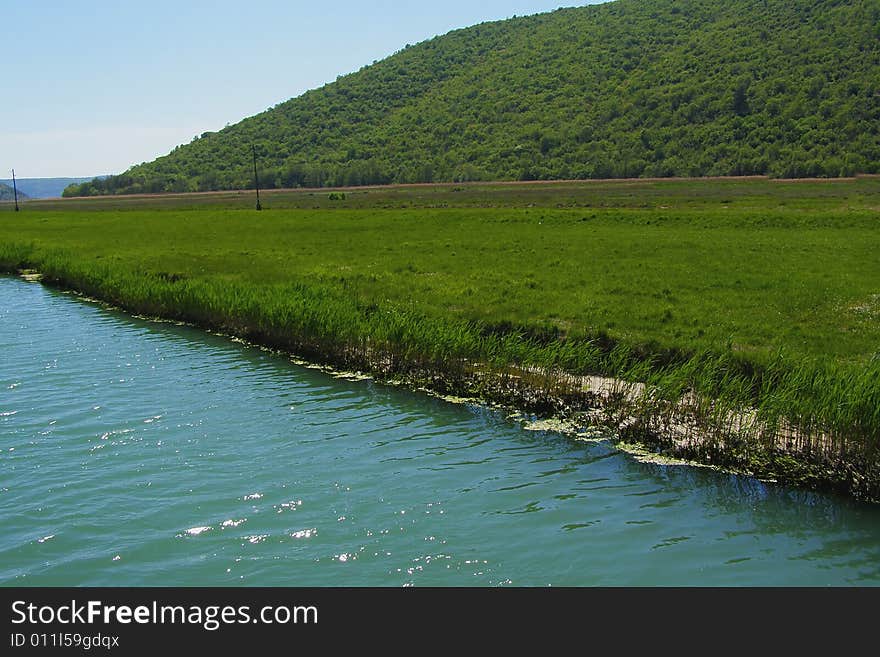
0;243;880;500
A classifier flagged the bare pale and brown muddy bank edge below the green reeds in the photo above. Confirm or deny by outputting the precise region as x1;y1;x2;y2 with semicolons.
0;264;880;503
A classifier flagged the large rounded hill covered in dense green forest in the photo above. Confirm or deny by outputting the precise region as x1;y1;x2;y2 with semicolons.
66;0;880;195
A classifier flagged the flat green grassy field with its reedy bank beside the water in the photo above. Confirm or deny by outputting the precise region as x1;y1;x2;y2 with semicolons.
0;179;880;499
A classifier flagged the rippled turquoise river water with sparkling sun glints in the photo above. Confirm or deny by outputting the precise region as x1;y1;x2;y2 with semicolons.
0;277;880;586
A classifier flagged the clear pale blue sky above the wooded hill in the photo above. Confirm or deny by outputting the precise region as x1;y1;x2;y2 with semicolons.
0;0;597;178
